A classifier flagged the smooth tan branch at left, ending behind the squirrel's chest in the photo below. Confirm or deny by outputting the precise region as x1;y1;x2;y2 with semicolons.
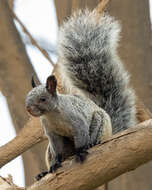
0;118;46;168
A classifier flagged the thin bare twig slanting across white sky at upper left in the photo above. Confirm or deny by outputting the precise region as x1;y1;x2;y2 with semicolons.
11;9;55;67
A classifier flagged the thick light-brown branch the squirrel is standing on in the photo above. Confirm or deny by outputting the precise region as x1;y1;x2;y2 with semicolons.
27;120;152;190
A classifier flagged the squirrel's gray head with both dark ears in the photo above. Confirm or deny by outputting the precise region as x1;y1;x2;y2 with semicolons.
26;75;57;117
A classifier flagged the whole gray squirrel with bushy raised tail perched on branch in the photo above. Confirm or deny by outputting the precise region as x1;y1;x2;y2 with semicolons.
26;10;137;180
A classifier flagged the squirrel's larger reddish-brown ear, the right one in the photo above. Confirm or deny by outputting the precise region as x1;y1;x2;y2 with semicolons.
46;75;57;96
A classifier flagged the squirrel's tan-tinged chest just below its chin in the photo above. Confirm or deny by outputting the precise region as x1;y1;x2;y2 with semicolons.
41;113;72;137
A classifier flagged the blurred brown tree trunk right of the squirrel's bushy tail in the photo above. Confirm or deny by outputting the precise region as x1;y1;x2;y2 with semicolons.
109;0;152;111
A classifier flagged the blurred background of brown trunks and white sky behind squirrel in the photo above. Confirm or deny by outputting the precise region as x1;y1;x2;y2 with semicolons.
0;0;152;190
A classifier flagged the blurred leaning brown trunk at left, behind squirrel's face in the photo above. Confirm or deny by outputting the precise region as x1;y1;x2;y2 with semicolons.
0;0;45;185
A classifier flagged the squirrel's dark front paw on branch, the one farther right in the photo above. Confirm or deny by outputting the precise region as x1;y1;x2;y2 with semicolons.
75;147;88;163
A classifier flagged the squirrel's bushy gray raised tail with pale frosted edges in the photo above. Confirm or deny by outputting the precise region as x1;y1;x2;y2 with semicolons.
58;10;136;133
